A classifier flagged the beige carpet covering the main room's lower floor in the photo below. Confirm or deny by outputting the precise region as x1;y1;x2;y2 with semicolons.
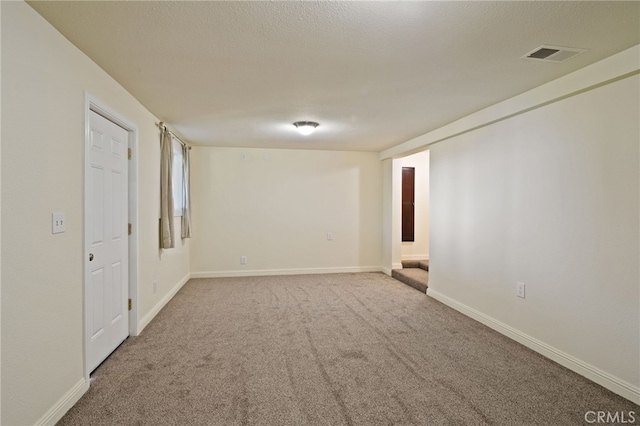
59;273;640;425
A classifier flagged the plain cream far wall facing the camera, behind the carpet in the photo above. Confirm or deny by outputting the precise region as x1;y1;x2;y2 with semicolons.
191;147;382;276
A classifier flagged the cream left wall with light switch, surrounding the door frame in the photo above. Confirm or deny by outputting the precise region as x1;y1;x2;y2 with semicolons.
0;2;189;425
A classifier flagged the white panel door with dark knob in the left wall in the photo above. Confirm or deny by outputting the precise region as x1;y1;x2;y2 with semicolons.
85;111;129;371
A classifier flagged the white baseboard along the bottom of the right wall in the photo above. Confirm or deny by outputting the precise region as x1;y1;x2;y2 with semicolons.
427;288;640;405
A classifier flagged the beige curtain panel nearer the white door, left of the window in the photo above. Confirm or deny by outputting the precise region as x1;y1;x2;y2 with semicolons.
160;129;174;249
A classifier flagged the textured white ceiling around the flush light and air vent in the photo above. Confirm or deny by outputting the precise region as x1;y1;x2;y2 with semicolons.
29;1;640;151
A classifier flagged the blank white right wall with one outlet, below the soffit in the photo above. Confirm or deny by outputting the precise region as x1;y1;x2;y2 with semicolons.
429;73;640;403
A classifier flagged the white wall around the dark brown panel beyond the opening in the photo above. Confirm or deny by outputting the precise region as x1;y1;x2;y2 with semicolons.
393;151;429;260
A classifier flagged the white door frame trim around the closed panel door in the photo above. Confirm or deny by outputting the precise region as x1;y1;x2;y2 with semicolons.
82;92;139;384
